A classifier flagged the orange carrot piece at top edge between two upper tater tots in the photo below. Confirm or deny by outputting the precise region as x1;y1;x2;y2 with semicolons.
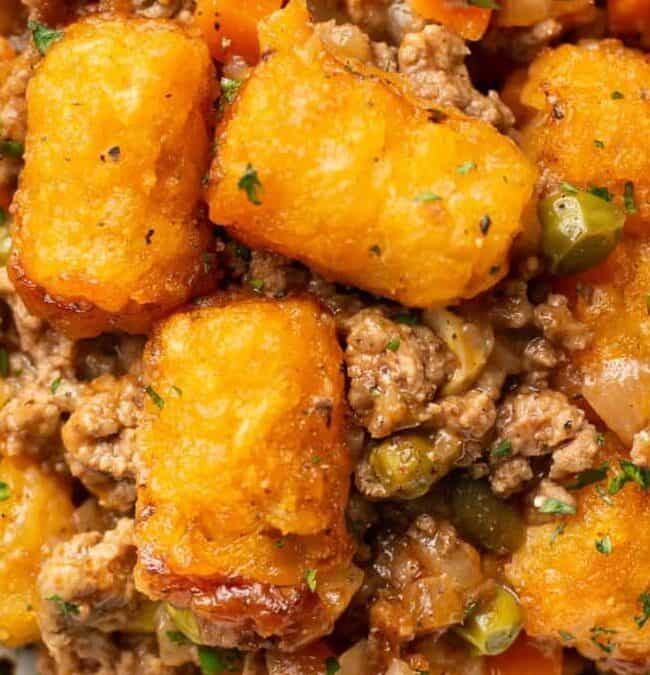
194;0;282;65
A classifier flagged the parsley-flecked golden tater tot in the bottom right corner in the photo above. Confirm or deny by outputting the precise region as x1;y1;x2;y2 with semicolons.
506;446;650;667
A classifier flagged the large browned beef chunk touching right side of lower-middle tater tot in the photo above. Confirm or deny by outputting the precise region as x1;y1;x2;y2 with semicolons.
345;309;452;438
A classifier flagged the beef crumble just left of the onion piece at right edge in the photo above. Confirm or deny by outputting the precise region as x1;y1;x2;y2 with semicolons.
497;389;585;457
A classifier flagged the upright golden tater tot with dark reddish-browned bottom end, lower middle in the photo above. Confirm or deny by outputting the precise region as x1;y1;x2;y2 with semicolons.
136;298;358;647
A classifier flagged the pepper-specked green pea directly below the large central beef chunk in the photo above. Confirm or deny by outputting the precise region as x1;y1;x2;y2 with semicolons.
369;432;461;499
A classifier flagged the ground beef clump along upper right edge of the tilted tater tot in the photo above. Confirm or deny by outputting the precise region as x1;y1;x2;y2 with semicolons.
398;24;515;130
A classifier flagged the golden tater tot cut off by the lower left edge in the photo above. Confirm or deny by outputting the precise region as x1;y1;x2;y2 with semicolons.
0;457;73;647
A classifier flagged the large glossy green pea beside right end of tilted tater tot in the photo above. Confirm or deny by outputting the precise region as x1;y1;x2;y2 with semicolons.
537;190;625;274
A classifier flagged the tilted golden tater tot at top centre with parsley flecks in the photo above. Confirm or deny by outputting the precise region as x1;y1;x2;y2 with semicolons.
209;0;535;306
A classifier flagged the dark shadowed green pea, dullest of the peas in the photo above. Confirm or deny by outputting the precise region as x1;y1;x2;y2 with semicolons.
449;476;525;554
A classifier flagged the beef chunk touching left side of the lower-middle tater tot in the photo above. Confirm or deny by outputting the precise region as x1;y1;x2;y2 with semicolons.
62;375;143;511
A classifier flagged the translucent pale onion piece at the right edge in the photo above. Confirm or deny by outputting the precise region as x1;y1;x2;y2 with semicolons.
582;358;650;446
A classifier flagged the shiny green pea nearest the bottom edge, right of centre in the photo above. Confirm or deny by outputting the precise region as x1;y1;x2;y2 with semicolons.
455;586;523;655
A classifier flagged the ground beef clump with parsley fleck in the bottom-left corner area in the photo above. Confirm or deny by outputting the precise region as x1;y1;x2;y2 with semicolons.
38;518;191;675
